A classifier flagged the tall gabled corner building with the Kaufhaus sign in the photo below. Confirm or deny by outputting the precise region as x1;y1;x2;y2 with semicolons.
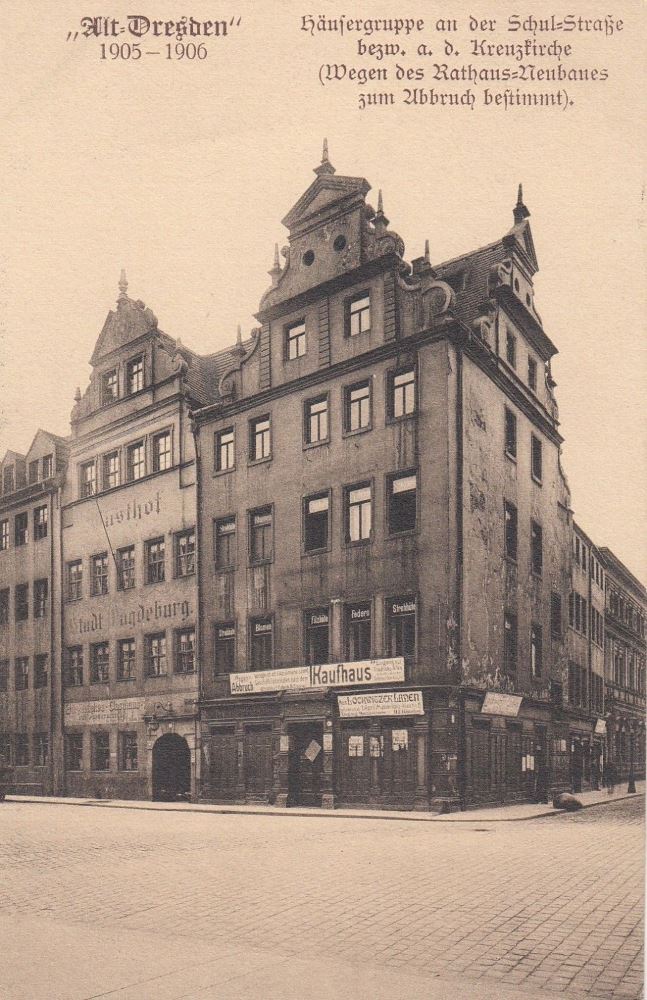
193;148;571;809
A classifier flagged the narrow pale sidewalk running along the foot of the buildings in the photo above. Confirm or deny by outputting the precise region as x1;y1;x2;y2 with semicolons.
7;781;645;823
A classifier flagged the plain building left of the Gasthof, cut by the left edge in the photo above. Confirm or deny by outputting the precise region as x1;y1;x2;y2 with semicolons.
0;430;68;795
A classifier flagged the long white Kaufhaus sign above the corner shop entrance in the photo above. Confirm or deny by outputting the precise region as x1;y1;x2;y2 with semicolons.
229;656;404;694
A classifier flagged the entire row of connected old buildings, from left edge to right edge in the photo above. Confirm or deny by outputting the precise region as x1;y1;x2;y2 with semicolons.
0;153;647;809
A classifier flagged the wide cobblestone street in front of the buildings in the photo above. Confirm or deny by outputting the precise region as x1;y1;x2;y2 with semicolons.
0;797;644;1000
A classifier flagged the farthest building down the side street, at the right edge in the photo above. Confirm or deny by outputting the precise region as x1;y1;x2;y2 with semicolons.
600;548;647;778
